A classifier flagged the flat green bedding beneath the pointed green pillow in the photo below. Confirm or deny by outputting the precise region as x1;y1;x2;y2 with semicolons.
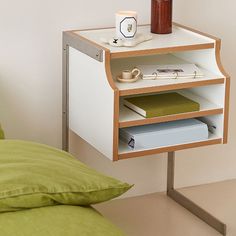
0;205;124;236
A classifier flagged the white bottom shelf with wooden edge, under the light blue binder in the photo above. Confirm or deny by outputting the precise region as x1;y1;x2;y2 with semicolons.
118;133;223;160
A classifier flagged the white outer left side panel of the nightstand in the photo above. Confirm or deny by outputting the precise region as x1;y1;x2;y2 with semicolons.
69;48;114;159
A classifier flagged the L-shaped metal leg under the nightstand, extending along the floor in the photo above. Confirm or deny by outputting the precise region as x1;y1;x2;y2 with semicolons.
167;152;226;235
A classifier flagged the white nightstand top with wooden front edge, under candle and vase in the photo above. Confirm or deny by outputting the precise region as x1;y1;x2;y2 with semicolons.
74;24;215;58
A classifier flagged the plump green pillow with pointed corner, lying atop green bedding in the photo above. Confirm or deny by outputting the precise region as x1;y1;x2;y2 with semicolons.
0;140;131;212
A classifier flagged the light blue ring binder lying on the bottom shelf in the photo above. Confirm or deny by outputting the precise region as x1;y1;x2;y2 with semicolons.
120;119;208;150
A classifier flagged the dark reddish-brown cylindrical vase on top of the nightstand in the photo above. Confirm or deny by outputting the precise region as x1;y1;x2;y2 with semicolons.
151;0;172;34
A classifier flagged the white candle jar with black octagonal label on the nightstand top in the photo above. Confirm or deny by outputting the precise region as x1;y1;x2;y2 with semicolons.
116;11;137;39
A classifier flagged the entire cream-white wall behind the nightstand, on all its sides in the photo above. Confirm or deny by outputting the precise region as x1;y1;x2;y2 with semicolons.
0;0;236;195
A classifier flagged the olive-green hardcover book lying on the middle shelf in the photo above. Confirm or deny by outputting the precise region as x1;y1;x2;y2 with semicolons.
124;93;200;118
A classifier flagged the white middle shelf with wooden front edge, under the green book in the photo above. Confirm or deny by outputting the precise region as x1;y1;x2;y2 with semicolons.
119;90;223;128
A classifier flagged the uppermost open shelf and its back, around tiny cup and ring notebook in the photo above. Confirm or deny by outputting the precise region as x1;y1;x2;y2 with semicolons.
111;54;225;96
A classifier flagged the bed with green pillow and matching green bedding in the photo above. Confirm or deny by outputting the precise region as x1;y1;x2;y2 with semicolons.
0;134;132;236
